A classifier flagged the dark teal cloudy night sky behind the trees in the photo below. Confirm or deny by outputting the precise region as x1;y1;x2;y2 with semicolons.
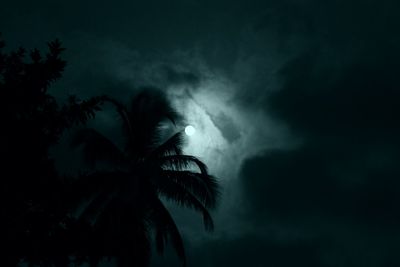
0;0;400;267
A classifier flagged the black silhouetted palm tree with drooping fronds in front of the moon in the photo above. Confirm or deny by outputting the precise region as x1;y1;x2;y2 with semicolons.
74;88;219;266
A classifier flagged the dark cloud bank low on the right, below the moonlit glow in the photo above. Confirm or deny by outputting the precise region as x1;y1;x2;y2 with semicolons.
242;146;400;224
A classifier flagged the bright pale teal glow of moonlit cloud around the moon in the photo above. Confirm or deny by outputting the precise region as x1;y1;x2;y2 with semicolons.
169;75;286;181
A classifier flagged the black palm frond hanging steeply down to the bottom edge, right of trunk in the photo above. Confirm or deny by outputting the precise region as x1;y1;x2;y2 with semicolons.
151;197;186;266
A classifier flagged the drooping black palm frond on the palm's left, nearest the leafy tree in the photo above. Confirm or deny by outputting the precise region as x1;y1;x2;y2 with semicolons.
71;128;125;168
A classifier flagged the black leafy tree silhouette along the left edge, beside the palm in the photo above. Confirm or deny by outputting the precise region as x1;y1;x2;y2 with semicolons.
0;36;101;266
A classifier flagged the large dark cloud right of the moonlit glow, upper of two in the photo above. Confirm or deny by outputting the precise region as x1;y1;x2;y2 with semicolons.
265;54;400;139
